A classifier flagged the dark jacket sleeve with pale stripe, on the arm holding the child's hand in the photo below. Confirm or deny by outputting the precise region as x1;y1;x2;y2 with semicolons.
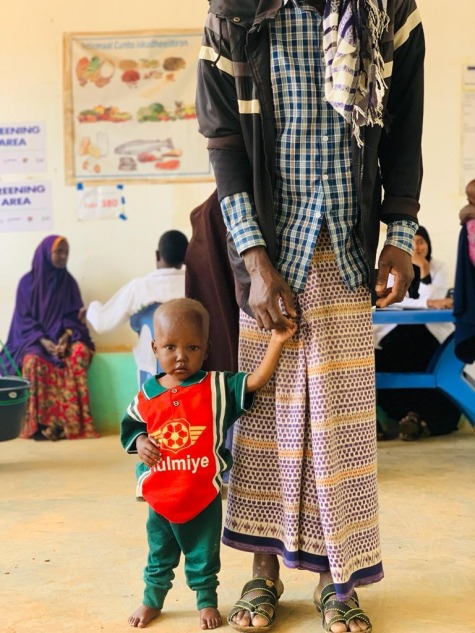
196;13;253;200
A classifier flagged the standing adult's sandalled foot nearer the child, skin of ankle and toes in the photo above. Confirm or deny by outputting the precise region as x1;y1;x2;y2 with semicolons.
230;554;284;630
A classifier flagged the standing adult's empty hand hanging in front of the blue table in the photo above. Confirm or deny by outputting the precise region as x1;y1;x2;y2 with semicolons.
375;245;414;308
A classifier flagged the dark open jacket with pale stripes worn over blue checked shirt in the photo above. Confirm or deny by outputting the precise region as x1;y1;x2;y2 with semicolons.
196;0;425;306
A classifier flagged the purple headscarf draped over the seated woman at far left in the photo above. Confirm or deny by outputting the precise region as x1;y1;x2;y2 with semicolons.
0;235;94;373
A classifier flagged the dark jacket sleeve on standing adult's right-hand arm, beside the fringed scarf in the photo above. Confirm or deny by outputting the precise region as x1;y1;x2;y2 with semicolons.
379;0;425;222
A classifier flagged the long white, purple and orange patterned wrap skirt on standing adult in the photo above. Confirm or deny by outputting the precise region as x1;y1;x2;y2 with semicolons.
223;227;383;599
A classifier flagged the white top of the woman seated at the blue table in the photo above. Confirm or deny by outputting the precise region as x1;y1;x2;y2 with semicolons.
373;259;455;349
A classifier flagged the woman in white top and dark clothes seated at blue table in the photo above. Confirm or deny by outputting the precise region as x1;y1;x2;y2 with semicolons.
374;226;460;440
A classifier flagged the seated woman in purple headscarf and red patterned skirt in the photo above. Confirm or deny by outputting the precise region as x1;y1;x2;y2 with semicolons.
3;235;97;440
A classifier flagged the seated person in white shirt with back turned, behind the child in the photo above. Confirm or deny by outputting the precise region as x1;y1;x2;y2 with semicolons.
86;230;188;384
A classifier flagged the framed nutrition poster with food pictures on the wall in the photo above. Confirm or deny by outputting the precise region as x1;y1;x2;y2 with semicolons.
64;31;213;185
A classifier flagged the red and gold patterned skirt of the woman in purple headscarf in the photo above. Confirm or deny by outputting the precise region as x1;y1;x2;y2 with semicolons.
20;341;98;440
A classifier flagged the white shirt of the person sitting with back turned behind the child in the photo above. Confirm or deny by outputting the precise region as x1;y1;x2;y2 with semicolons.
86;267;185;374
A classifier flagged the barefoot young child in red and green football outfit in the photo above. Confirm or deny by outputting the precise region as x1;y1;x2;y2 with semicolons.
121;299;296;629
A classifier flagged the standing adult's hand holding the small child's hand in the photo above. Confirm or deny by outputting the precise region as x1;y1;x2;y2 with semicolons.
243;246;296;330
